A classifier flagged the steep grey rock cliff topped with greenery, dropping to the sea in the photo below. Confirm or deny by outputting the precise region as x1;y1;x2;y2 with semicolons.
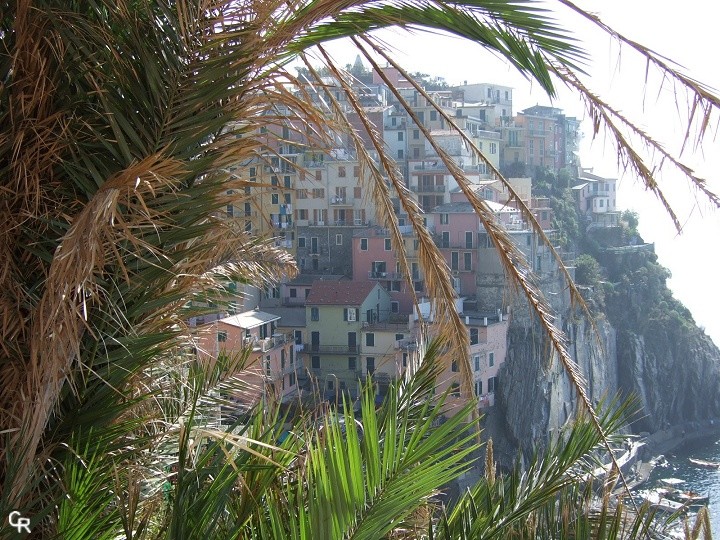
491;247;720;453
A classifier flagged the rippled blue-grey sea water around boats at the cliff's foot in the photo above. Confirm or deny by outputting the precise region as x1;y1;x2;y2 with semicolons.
643;437;720;538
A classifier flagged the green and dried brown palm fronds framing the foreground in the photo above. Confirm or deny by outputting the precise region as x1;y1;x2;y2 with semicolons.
0;0;720;539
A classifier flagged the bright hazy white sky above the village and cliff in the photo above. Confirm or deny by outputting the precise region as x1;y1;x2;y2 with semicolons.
322;0;720;345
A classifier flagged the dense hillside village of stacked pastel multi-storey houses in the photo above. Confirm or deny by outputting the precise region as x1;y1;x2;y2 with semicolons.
191;64;620;418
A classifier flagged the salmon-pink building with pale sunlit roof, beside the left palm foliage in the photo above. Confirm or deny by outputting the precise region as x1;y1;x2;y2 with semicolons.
197;309;303;406
